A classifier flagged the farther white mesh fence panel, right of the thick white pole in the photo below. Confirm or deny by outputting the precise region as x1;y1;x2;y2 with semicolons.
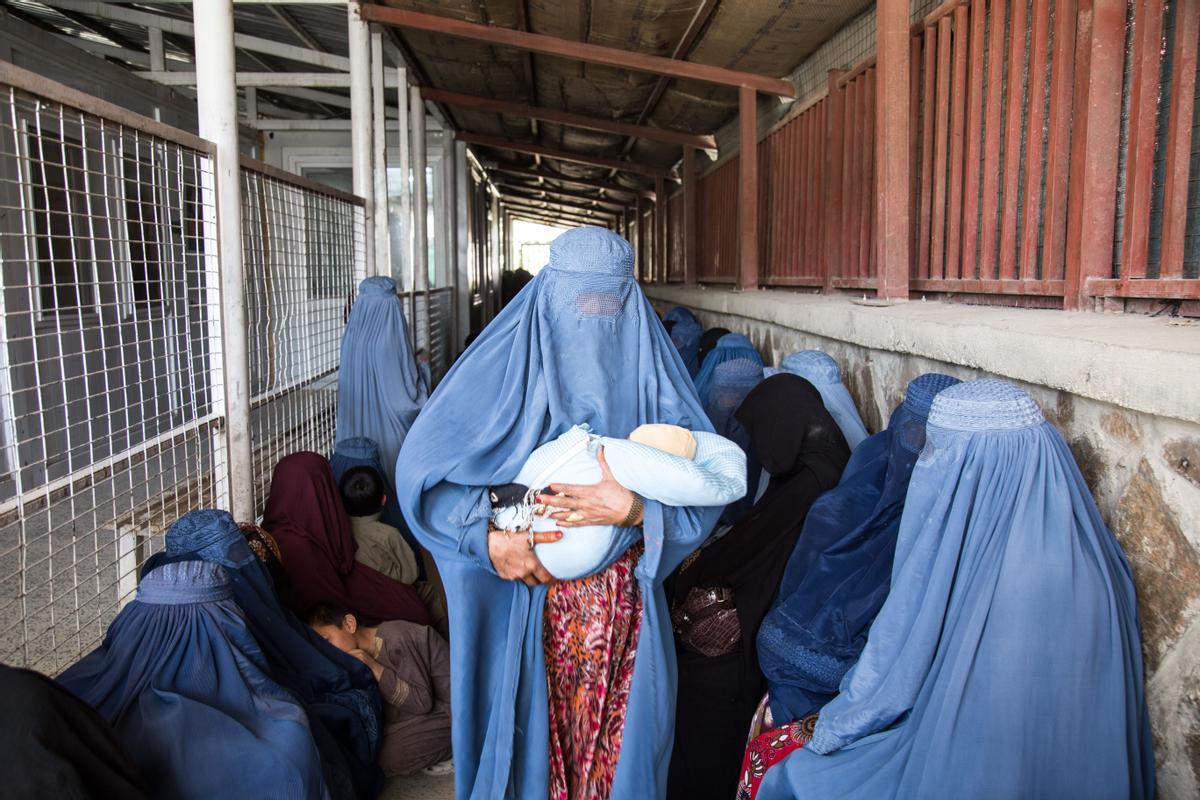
242;164;366;512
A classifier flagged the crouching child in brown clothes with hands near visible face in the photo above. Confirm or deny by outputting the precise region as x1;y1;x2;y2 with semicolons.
308;604;452;777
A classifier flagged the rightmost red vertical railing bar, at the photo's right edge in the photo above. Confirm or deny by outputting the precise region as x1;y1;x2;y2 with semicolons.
1158;0;1200;278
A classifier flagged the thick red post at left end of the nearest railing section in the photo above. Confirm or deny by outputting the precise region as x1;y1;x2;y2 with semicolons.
875;0;912;300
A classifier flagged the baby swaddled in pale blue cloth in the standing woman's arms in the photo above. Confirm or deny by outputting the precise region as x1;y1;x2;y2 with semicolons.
491;425;746;581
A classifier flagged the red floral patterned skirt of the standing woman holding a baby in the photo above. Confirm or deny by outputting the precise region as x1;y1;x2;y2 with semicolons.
542;545;642;800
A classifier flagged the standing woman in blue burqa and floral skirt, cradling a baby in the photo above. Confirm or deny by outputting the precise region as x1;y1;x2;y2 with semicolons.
396;228;719;800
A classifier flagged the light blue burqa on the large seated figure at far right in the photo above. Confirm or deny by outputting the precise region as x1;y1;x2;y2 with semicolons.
758;380;1154;800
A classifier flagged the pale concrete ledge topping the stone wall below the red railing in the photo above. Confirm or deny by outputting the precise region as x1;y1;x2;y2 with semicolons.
643;285;1200;422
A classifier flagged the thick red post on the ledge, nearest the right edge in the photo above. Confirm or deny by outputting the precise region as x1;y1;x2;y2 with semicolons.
1063;0;1126;309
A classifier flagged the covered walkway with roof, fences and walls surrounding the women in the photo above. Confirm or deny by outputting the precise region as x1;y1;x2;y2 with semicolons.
0;0;1200;799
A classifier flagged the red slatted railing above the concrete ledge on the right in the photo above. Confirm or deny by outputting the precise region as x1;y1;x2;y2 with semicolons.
670;0;1200;308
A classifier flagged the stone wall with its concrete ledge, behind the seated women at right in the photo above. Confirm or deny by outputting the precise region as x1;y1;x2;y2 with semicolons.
647;287;1200;800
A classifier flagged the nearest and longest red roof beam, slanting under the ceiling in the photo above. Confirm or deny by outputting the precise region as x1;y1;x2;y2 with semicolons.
362;5;796;97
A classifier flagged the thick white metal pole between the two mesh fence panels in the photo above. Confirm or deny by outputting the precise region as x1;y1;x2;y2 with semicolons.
192;0;256;519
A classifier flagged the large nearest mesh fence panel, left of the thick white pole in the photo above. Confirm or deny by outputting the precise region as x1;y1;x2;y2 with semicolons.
0;72;226;674
